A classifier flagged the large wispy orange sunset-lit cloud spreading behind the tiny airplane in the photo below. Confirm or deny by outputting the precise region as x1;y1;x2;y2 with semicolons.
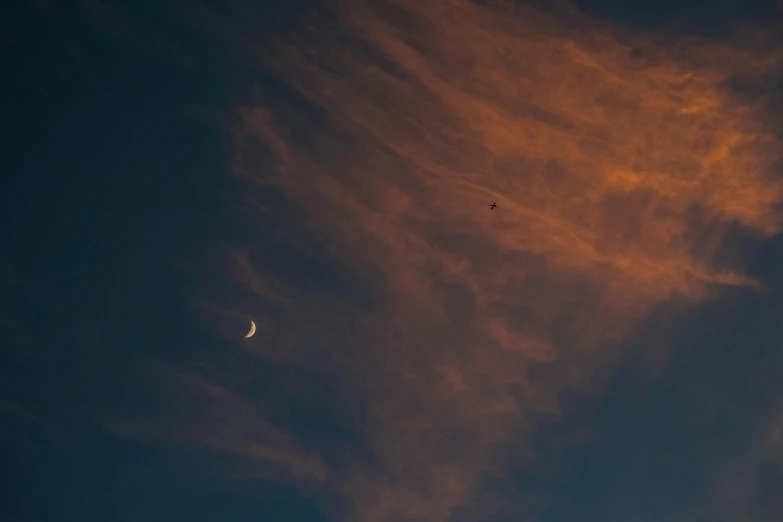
119;0;783;522
